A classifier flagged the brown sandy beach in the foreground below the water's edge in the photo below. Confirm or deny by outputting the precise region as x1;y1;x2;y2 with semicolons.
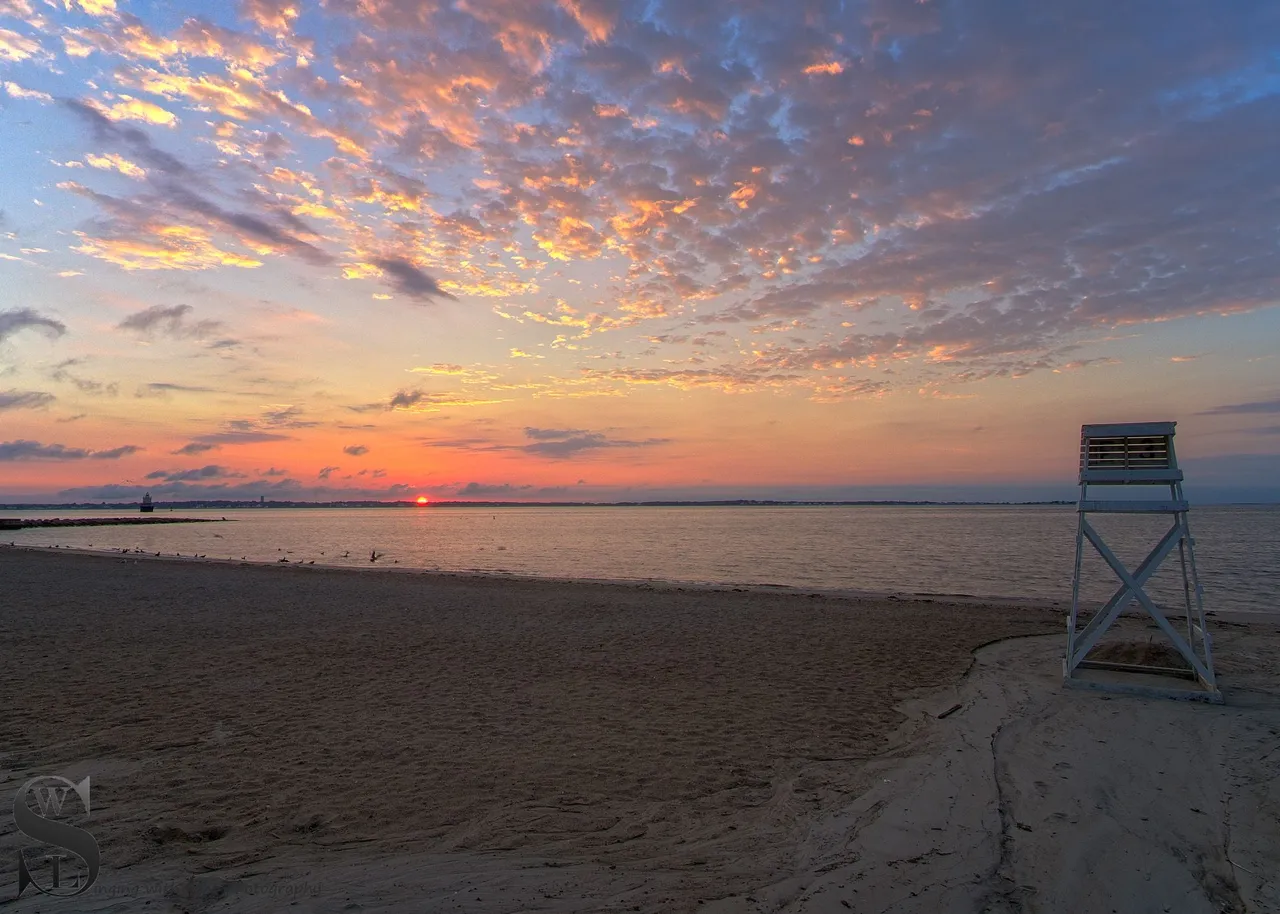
0;549;1280;914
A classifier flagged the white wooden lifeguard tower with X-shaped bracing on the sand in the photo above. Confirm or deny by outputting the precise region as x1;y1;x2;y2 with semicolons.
1062;422;1222;703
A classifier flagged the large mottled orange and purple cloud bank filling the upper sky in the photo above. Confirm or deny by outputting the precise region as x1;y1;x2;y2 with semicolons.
0;0;1280;410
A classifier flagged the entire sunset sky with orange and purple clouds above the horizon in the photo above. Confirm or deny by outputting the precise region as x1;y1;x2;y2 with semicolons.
0;0;1280;502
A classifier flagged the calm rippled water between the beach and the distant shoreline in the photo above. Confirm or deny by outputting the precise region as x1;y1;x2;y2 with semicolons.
4;506;1280;612
